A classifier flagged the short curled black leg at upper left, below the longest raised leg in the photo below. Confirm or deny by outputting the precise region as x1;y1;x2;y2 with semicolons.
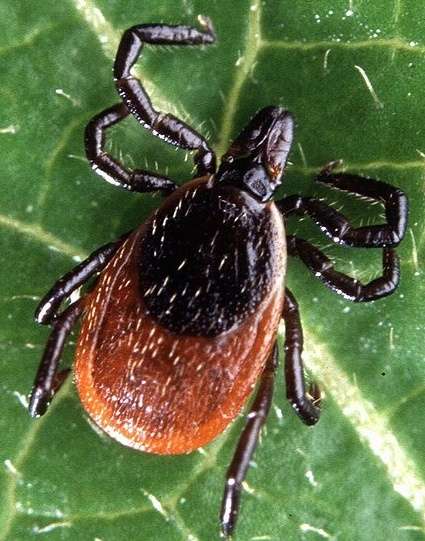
85;103;176;193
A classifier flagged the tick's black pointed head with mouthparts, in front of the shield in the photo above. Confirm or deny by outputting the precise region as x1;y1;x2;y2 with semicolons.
216;106;294;202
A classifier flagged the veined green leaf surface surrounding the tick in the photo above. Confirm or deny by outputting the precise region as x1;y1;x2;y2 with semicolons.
0;0;425;541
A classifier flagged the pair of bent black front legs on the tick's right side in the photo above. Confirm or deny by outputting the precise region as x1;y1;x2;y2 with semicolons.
277;162;408;302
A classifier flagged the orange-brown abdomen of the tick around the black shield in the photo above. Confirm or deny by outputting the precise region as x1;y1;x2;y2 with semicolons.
75;179;285;454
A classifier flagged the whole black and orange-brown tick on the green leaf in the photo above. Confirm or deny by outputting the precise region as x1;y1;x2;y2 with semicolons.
29;18;408;536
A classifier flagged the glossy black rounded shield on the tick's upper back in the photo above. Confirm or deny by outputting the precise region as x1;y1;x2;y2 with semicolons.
138;183;282;337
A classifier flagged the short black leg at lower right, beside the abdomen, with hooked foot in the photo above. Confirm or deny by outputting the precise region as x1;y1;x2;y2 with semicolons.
282;289;320;425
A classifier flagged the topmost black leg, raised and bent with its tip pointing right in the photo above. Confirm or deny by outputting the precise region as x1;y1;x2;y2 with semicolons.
114;18;216;176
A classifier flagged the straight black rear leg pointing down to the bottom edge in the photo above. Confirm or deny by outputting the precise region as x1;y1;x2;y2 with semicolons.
220;345;277;538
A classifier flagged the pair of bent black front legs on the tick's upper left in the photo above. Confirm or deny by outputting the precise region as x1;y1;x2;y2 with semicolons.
85;18;216;194
